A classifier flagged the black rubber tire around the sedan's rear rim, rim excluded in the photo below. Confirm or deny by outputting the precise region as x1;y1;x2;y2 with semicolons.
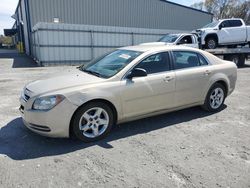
203;83;226;112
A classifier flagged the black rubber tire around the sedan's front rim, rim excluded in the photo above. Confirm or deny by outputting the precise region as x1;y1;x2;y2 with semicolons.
71;102;114;142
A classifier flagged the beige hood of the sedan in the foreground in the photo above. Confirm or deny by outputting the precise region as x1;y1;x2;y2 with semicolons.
26;69;104;96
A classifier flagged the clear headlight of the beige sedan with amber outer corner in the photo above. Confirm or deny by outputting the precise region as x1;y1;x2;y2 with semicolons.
32;95;65;110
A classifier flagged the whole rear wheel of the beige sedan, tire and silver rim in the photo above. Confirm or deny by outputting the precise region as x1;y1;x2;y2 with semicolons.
202;83;226;112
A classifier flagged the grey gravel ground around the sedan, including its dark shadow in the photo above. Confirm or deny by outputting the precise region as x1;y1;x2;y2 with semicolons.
0;51;250;188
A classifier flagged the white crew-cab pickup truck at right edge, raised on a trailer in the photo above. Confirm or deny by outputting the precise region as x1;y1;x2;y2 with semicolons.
196;18;250;49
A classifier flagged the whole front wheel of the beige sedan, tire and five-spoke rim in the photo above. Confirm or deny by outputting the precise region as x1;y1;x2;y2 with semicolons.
72;102;114;142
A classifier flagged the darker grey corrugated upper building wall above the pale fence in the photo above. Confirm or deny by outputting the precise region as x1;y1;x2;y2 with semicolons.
29;0;212;30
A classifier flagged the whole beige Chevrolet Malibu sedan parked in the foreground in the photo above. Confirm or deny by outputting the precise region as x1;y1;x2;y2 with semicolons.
20;46;237;142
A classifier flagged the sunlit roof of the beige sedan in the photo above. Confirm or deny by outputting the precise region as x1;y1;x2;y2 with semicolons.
119;45;200;52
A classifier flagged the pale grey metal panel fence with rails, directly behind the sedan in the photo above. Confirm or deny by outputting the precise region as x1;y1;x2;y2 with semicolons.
32;23;184;65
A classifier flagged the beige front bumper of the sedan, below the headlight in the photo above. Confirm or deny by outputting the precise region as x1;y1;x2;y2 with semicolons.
19;98;78;138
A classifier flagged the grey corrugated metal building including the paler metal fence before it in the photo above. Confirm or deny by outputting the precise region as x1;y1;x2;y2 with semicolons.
12;0;213;63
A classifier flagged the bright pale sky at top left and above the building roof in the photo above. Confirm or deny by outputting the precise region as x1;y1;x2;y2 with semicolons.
0;0;201;34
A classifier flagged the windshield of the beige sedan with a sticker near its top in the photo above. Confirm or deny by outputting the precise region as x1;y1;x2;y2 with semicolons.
80;50;142;78
